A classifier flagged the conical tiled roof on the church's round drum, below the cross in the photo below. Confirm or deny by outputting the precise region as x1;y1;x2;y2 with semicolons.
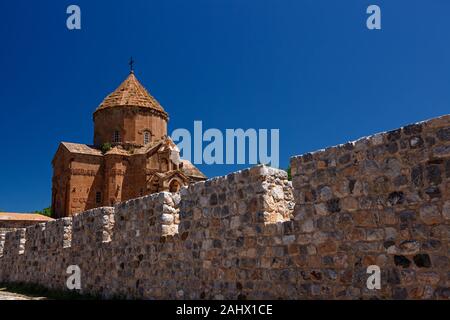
97;72;165;113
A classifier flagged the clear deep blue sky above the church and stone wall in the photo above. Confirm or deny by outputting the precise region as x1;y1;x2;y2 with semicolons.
0;0;450;212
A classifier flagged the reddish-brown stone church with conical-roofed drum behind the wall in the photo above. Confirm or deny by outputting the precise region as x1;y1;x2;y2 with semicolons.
52;70;206;218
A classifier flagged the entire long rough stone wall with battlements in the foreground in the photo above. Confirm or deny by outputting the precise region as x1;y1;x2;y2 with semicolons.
0;116;450;300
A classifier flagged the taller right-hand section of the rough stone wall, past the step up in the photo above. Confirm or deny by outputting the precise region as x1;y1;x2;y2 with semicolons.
291;116;450;299
